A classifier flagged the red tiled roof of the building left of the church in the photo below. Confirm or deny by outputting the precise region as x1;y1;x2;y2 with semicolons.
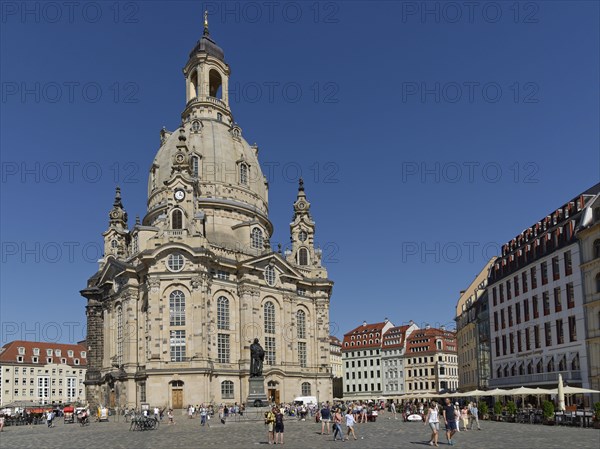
0;340;87;367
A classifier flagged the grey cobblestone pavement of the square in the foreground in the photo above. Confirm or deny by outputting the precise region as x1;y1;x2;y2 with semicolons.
0;415;600;449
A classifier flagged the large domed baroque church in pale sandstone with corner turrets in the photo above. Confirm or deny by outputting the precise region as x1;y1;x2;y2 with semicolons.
81;17;333;408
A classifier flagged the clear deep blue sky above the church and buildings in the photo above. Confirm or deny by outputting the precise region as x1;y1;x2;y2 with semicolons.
0;1;600;343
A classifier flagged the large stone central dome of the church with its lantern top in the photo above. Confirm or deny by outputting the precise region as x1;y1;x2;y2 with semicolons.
143;14;273;256
